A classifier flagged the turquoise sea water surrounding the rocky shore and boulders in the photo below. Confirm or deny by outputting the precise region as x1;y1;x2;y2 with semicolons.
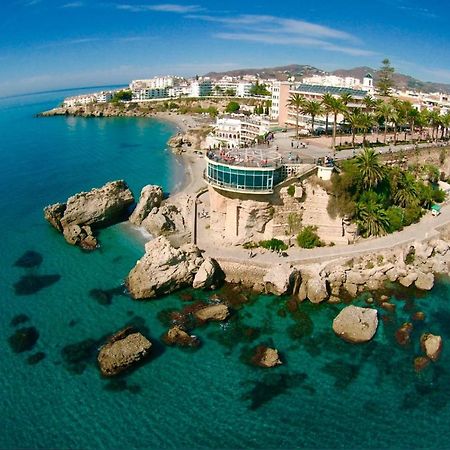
0;89;450;449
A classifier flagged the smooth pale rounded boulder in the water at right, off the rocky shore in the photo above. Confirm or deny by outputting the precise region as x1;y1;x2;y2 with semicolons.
333;305;378;344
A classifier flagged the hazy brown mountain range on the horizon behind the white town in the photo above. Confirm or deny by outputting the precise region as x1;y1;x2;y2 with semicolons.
206;64;450;93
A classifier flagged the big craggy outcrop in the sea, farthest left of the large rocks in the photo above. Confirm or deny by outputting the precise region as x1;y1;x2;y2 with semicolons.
44;180;134;250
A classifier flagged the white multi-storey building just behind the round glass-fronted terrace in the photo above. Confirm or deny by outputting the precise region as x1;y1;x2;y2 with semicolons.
206;114;270;148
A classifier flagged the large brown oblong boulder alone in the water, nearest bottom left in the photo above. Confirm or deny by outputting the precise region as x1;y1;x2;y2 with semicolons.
97;328;152;377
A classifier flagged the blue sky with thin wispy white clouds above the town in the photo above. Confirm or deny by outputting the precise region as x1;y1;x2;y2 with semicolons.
0;0;450;96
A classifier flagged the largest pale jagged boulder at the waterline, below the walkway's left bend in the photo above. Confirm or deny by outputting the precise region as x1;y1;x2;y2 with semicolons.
126;236;203;299
